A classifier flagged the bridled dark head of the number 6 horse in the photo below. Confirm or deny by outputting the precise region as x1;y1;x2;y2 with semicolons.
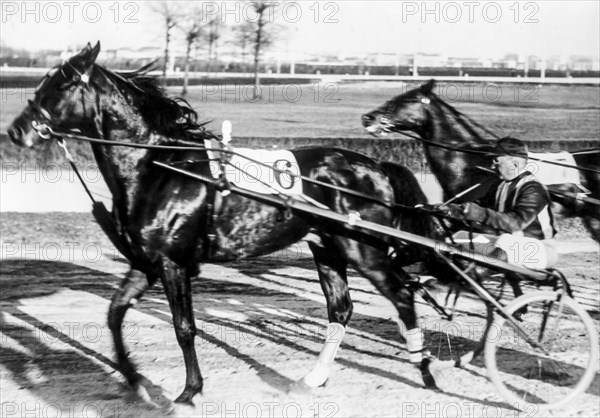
7;42;100;147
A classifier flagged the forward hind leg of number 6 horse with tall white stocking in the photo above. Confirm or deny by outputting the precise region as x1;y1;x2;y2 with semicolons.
303;243;352;387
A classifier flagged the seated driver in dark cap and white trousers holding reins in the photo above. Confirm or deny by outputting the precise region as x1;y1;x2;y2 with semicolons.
437;136;557;269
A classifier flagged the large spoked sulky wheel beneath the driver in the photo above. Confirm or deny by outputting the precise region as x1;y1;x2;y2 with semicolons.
485;291;599;410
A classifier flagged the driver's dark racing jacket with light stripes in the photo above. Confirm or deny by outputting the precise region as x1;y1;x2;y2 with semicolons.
479;171;556;240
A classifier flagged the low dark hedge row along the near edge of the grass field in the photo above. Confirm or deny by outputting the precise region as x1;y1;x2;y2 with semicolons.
0;134;600;169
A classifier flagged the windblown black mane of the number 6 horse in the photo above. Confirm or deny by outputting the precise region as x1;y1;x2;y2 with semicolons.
96;64;215;140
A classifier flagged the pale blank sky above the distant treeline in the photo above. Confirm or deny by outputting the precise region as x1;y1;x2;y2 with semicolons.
0;0;600;58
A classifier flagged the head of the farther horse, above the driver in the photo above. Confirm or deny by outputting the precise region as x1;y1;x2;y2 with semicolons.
362;80;435;136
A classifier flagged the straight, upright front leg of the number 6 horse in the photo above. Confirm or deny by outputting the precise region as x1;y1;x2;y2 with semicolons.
161;257;203;405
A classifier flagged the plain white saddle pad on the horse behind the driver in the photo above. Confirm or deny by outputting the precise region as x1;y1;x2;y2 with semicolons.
527;151;589;193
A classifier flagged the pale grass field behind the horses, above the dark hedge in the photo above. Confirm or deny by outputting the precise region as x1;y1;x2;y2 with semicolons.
0;82;600;161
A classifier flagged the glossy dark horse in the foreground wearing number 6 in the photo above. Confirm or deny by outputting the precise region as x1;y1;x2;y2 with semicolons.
8;44;440;403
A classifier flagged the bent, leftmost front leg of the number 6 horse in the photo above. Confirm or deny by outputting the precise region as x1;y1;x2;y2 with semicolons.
108;270;149;386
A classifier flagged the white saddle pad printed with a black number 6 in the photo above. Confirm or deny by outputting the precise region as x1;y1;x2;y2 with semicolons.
207;144;302;195
